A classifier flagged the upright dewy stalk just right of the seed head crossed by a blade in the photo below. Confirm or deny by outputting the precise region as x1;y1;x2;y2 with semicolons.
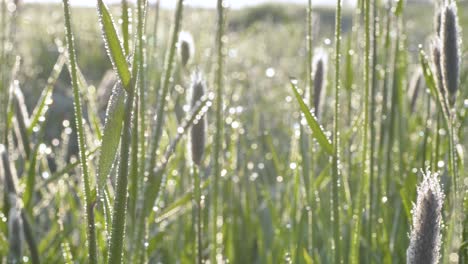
211;0;224;263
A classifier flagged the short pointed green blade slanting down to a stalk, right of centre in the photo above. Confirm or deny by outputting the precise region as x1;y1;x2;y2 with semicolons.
291;82;333;155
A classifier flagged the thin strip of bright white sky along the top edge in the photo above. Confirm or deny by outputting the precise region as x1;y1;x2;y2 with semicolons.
26;0;340;8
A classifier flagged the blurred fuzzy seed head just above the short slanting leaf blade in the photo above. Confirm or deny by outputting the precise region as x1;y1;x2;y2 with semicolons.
313;49;328;117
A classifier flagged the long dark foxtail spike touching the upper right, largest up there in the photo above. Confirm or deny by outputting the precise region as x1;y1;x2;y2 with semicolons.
440;2;461;106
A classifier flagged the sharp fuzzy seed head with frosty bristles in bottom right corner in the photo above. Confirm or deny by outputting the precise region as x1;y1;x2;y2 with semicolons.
406;171;444;264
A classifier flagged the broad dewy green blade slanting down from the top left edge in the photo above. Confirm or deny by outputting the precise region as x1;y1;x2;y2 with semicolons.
97;0;131;89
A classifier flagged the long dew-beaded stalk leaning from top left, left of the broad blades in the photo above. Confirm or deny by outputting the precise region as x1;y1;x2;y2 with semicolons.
63;0;98;264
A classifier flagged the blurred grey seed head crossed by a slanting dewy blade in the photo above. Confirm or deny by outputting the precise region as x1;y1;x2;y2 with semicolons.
190;73;206;166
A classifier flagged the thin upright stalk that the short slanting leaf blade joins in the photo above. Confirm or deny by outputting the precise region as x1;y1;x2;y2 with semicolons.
331;0;342;263
